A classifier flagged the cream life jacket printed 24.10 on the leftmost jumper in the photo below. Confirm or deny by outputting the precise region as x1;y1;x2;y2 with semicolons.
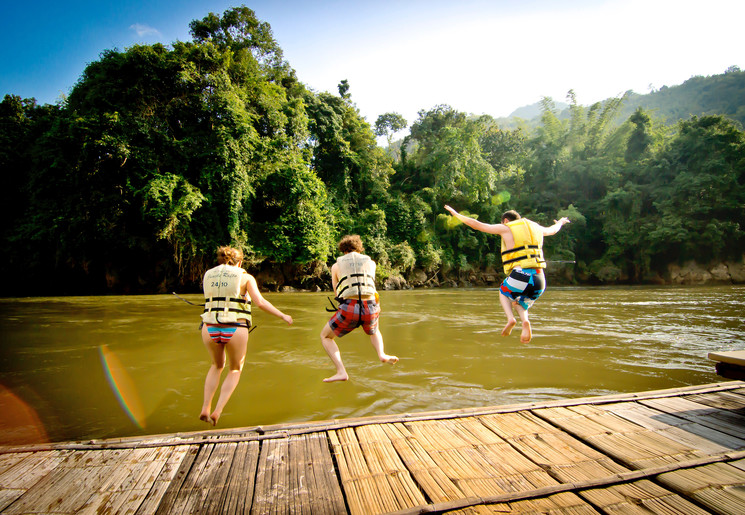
202;265;251;325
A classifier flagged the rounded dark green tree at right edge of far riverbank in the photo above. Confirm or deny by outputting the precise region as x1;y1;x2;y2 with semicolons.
646;116;745;265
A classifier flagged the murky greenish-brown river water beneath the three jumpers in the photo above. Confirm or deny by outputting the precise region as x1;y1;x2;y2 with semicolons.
0;284;745;444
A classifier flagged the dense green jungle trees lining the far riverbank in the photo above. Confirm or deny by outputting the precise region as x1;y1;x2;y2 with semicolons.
0;7;745;294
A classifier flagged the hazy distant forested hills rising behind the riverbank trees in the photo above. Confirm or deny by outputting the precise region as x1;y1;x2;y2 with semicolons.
497;66;745;128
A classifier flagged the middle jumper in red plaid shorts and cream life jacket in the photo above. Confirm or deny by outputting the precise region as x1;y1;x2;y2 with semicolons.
321;234;398;383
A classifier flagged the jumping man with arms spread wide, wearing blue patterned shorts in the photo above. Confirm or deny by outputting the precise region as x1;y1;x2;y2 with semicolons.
445;206;569;343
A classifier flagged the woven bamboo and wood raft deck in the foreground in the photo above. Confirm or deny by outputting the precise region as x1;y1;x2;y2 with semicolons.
0;381;745;515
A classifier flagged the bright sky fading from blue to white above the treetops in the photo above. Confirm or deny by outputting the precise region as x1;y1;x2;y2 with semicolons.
0;0;745;123
